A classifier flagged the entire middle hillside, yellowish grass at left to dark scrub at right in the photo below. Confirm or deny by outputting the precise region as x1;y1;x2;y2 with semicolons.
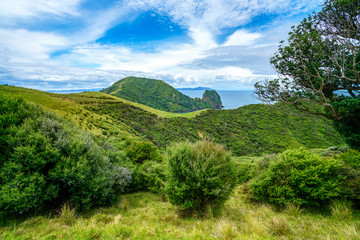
0;86;343;156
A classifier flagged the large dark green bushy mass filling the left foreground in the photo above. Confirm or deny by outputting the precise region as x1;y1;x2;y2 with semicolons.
0;97;130;214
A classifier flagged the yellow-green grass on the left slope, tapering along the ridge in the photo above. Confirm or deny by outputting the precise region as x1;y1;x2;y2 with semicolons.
0;85;206;149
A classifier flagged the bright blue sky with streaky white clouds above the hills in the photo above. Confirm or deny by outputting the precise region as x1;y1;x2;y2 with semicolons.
0;0;322;90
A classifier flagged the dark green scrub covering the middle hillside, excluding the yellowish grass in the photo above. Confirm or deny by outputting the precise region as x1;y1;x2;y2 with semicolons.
92;102;342;156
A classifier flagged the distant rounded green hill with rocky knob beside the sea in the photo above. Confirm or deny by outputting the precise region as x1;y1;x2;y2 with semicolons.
101;77;222;112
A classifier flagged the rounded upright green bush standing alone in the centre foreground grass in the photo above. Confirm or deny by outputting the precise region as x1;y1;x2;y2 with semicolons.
165;141;237;212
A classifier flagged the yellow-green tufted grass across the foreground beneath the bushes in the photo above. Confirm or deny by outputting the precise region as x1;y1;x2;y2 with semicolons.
0;187;360;240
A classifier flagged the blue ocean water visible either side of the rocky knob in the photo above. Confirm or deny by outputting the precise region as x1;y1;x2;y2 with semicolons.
179;90;261;109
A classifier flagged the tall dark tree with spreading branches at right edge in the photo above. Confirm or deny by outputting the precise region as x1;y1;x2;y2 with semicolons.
255;0;360;148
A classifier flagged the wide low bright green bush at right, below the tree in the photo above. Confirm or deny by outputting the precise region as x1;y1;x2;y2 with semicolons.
249;149;349;206
